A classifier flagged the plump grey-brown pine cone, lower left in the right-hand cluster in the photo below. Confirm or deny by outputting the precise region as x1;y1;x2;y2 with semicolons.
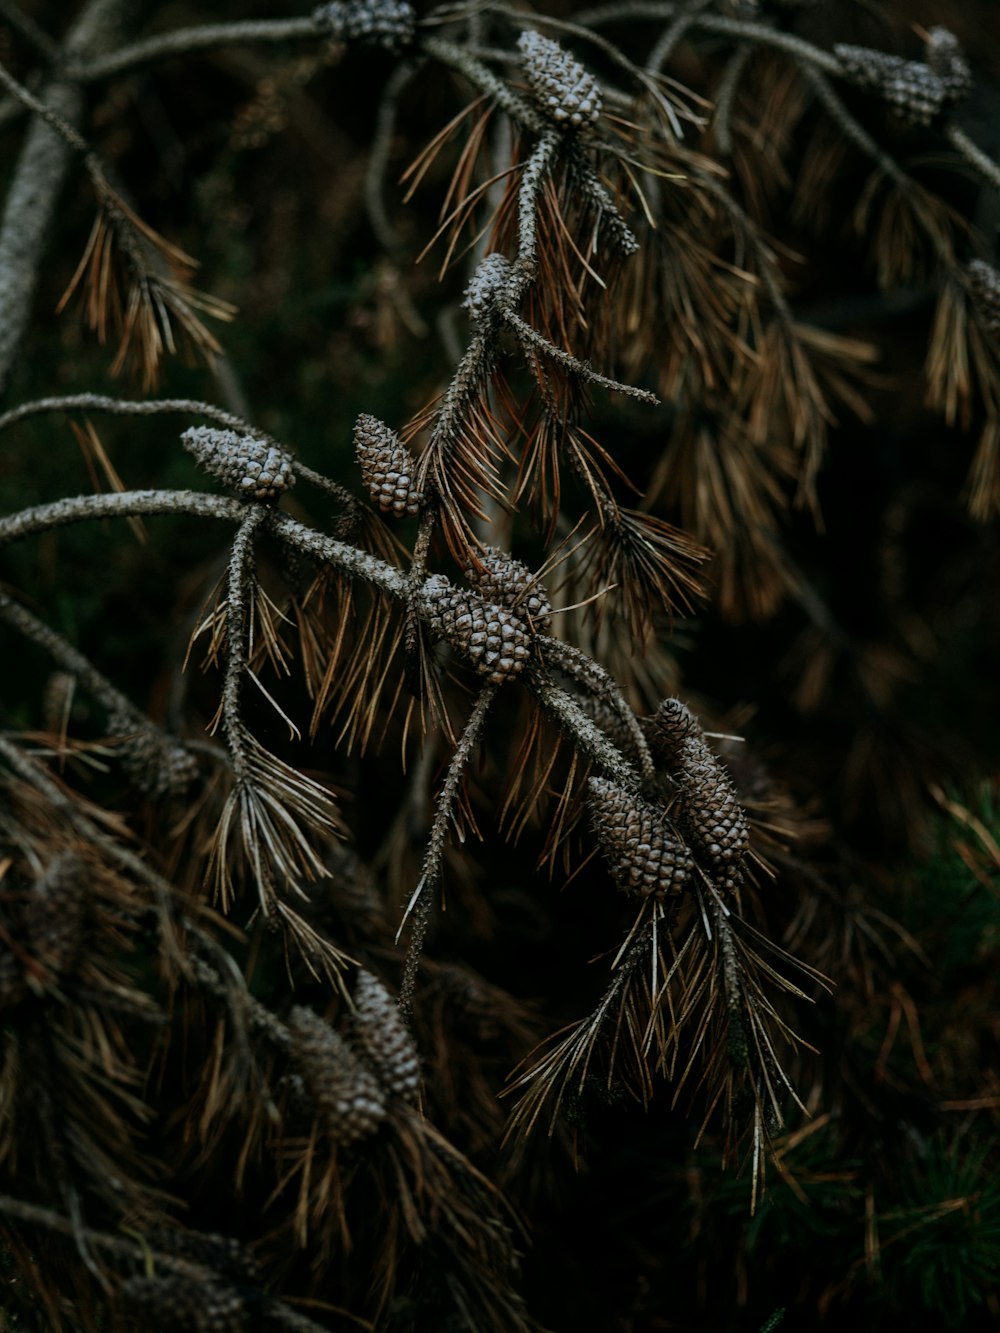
587;777;693;898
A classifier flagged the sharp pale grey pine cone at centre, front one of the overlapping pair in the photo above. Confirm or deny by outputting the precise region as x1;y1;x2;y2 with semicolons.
419;575;531;685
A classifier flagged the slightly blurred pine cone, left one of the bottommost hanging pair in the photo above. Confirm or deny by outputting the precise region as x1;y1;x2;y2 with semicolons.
288;1006;385;1146
